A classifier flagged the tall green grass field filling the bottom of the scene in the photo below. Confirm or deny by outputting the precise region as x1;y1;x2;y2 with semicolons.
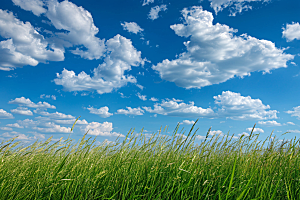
0;119;300;200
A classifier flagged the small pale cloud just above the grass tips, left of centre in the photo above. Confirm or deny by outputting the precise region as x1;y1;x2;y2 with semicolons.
82;122;125;137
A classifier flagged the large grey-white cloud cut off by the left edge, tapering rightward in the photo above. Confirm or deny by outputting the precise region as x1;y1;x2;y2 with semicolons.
0;9;64;71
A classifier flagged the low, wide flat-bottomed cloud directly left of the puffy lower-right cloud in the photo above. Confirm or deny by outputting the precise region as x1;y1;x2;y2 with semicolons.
143;98;214;117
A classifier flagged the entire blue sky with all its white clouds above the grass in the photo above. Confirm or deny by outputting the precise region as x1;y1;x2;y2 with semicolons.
0;0;300;148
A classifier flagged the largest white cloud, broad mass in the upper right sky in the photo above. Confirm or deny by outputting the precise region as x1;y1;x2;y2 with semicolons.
152;6;294;89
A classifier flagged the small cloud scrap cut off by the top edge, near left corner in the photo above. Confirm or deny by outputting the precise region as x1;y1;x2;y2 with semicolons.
12;0;47;16
